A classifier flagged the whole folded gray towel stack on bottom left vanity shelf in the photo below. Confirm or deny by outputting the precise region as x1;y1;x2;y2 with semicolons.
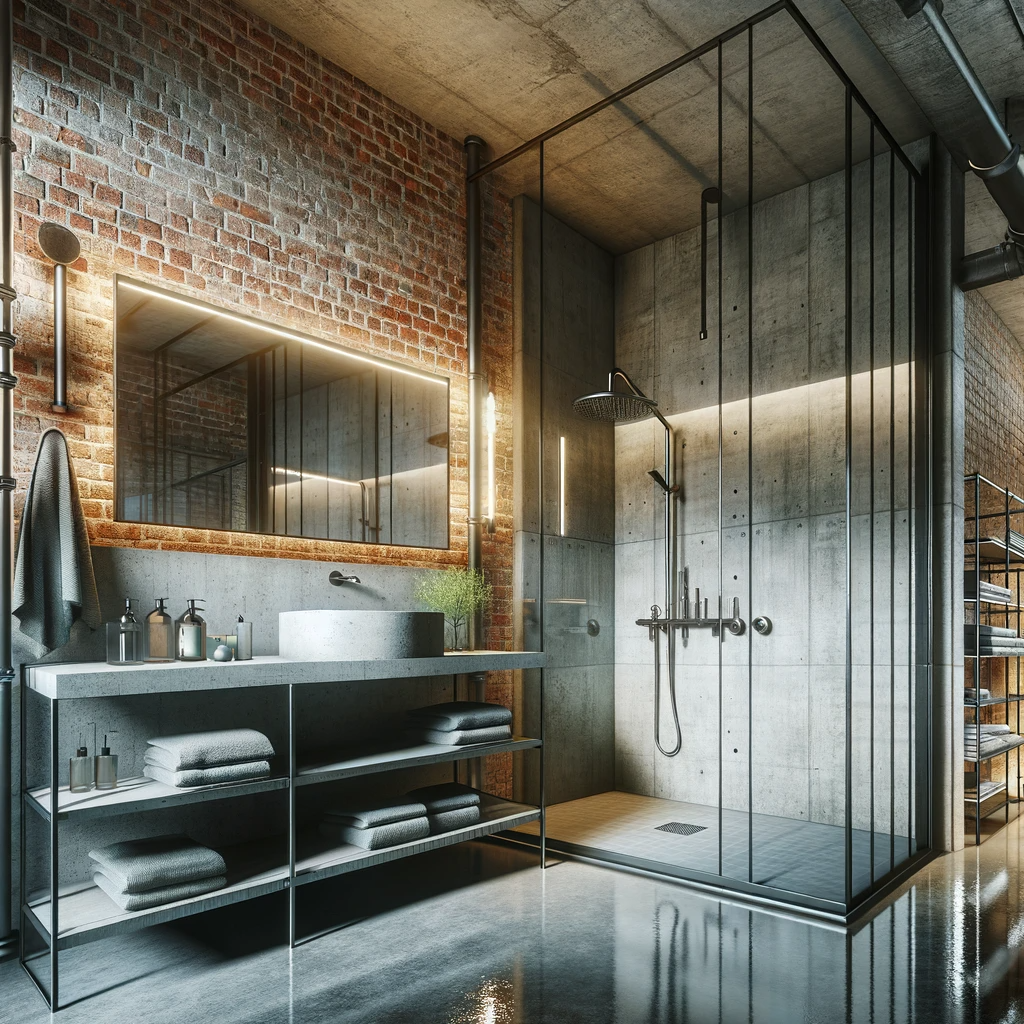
89;836;227;910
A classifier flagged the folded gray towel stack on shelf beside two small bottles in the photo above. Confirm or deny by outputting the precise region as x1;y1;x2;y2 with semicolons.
143;729;273;788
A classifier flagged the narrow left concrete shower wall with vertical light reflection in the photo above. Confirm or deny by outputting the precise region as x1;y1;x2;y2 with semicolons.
514;198;614;804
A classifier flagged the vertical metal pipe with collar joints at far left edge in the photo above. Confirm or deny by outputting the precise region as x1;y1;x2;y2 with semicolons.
0;0;17;948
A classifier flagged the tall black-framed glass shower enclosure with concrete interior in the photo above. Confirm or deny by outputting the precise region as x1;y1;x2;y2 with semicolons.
478;3;930;919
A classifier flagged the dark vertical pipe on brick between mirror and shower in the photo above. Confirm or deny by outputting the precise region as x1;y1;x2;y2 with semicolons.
464;135;487;649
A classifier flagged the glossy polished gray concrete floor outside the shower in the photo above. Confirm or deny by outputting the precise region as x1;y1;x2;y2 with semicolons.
0;820;1024;1024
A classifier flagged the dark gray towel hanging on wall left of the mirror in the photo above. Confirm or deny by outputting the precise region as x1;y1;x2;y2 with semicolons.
12;430;102;658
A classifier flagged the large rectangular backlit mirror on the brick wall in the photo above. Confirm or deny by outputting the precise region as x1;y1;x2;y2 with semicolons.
114;278;449;548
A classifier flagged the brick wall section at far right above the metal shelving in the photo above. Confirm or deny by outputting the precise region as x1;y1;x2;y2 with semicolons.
964;292;1024;495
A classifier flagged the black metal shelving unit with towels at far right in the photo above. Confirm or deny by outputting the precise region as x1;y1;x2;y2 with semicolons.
964;473;1024;845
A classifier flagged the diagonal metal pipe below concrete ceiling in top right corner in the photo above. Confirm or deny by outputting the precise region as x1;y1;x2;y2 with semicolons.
896;0;1024;243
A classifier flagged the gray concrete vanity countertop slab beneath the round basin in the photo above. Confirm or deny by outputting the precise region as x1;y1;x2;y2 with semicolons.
25;650;547;700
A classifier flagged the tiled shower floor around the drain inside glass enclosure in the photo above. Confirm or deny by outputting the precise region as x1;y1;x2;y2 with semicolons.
522;793;907;901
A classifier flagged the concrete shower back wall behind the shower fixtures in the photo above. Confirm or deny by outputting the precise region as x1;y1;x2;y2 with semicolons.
614;155;913;835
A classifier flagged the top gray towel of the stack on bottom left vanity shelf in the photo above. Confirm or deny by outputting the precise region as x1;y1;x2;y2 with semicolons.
89;836;227;893
